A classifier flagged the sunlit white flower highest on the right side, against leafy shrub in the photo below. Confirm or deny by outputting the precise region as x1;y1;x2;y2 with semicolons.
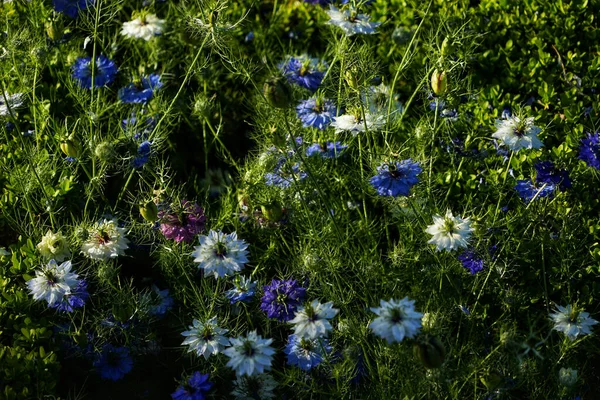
492;117;543;151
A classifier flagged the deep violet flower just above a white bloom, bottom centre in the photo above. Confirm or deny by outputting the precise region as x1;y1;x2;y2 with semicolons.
260;279;306;322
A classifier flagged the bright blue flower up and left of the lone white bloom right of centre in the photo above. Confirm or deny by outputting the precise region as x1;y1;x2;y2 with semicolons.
369;158;423;197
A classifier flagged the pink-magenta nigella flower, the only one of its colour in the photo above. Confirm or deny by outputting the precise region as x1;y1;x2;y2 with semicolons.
158;200;206;243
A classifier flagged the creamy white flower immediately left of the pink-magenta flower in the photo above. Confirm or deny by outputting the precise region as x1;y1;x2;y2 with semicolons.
81;219;129;260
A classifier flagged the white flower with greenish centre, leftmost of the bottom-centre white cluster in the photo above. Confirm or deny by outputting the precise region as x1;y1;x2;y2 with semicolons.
181;317;229;360
